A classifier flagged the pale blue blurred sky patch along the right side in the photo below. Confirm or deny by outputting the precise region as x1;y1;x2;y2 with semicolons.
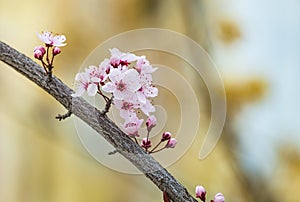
213;0;300;176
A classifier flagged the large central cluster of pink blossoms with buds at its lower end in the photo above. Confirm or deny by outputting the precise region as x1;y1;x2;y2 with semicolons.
72;48;176;153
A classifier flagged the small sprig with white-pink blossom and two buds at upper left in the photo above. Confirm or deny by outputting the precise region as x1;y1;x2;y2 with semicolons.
33;31;66;76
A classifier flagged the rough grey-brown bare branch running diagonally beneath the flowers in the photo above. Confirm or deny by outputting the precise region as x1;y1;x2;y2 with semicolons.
0;41;197;202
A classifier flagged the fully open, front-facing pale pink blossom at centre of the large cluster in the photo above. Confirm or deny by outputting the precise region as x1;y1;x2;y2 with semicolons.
102;69;141;100
